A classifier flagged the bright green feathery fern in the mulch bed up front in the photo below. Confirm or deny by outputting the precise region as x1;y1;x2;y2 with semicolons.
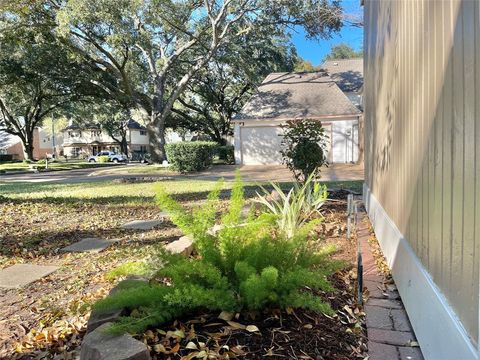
96;173;339;332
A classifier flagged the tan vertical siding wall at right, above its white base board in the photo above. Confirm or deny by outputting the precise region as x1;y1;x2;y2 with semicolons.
364;0;480;342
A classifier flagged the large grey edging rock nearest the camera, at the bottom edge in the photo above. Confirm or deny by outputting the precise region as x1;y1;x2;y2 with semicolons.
80;323;151;360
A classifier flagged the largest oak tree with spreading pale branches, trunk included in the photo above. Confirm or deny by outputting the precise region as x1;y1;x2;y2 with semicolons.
45;0;342;161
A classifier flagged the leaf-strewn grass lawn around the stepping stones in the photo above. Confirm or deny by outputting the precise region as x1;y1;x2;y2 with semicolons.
0;179;362;358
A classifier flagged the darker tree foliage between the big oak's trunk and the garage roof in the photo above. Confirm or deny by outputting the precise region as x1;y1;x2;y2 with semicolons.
167;32;297;145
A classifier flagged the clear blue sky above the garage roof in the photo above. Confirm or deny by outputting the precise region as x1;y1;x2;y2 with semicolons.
292;0;363;65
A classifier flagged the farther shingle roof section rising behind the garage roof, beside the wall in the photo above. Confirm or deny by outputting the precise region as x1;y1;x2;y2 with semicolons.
322;58;363;92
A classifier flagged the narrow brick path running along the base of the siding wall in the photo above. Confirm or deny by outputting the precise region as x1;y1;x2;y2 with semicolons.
357;213;423;360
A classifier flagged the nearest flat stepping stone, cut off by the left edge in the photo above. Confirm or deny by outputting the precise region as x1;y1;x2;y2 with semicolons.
0;264;58;289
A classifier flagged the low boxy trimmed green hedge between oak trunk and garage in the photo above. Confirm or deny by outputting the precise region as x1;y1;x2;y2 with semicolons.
165;141;218;173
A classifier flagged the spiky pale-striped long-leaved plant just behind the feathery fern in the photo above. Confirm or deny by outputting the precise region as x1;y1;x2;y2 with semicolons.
255;173;327;238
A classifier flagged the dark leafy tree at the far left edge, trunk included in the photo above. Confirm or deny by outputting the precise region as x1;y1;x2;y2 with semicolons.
0;8;94;160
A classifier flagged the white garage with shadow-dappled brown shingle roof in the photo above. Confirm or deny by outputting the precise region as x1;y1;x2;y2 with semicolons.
232;72;362;165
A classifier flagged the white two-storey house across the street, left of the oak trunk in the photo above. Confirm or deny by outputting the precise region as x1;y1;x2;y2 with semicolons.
63;120;149;158
